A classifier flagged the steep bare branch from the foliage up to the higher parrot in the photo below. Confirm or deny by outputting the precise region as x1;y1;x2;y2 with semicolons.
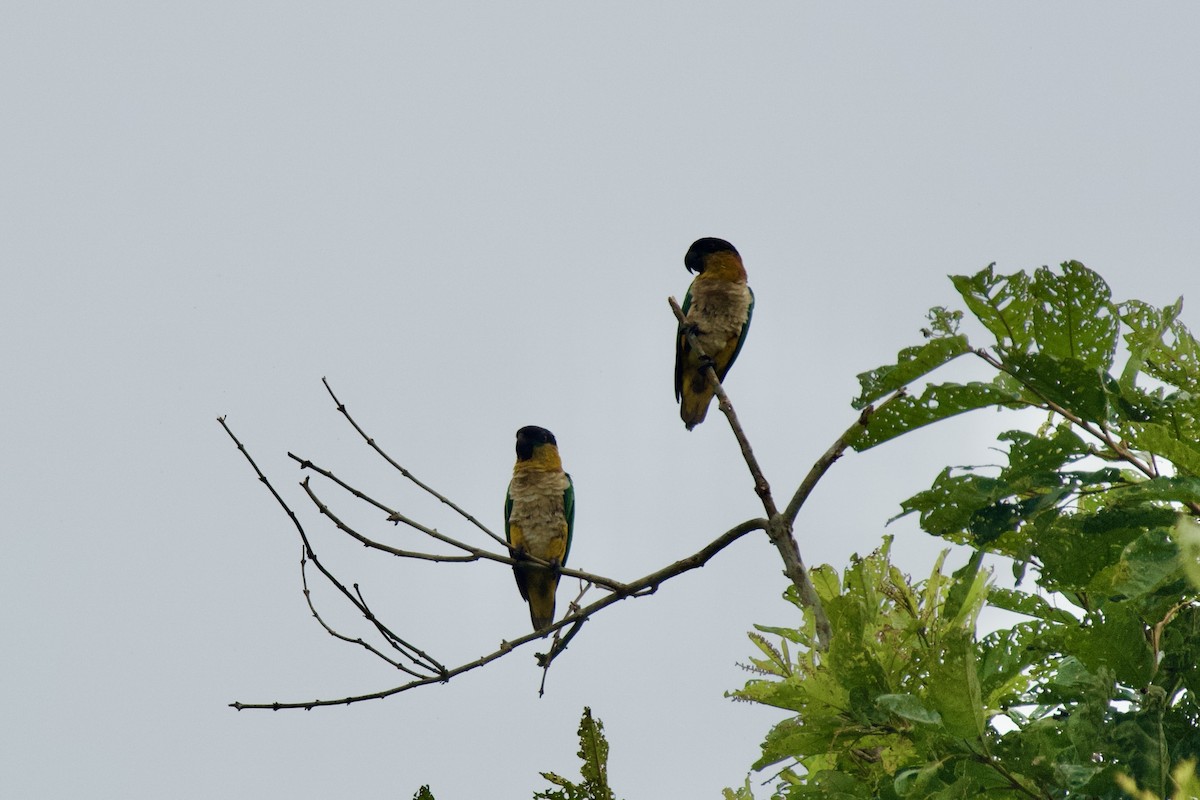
667;297;832;650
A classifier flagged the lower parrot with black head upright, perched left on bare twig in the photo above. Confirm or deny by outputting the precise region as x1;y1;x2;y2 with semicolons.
504;425;575;631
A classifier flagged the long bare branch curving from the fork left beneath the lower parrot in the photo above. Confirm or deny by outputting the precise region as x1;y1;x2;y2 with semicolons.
229;518;767;711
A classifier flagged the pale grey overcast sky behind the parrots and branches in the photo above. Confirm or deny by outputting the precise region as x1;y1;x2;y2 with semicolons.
0;1;1200;800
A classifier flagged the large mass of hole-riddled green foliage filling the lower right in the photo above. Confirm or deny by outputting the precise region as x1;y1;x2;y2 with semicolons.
726;261;1200;800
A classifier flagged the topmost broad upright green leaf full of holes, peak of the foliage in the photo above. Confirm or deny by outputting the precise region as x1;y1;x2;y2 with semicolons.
1031;261;1120;372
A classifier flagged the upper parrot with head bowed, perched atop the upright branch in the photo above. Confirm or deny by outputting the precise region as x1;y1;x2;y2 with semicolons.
676;237;754;431
